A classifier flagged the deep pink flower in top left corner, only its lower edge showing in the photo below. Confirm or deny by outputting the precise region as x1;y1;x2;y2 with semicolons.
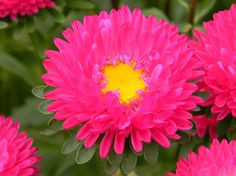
0;0;55;20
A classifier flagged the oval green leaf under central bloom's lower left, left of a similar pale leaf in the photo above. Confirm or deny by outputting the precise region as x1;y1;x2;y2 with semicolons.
61;134;81;154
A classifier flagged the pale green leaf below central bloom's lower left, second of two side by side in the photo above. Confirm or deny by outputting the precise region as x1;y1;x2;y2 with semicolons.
75;145;95;165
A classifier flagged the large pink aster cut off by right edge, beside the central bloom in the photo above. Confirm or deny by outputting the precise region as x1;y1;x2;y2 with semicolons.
192;5;236;120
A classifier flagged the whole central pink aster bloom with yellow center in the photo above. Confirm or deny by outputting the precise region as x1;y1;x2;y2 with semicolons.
42;6;202;158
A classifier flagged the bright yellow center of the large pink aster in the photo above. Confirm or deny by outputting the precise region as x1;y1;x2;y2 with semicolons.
102;62;146;104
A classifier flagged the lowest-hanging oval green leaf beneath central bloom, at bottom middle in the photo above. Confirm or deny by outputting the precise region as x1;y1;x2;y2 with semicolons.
121;149;137;174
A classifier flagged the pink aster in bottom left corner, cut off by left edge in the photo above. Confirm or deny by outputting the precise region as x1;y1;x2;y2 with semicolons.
0;115;40;176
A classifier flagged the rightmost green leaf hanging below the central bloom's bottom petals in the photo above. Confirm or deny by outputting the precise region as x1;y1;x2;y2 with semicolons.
144;142;158;164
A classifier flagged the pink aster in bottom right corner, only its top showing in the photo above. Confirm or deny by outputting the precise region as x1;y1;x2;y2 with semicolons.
166;139;236;176
